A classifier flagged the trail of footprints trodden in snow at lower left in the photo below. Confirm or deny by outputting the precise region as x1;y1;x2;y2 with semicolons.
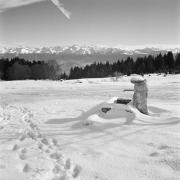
12;108;81;180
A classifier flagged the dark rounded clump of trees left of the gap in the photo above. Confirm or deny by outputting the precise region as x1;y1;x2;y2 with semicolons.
0;57;61;80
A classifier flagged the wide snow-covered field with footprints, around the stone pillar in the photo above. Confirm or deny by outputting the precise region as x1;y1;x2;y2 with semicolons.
0;75;180;180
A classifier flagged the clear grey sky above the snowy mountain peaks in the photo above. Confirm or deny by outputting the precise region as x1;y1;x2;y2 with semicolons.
0;0;180;47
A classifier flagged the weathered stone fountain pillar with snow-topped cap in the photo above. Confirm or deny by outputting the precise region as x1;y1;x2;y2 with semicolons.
131;77;148;114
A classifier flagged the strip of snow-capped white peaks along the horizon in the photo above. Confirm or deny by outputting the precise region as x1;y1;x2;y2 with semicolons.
0;45;180;55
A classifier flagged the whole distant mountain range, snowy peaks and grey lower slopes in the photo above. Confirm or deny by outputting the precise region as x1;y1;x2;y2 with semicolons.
0;45;180;71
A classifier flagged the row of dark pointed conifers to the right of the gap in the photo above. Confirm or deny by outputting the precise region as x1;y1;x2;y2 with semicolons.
69;52;180;79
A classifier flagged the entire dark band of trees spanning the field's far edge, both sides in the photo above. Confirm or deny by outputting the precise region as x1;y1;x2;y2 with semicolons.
0;52;180;80
